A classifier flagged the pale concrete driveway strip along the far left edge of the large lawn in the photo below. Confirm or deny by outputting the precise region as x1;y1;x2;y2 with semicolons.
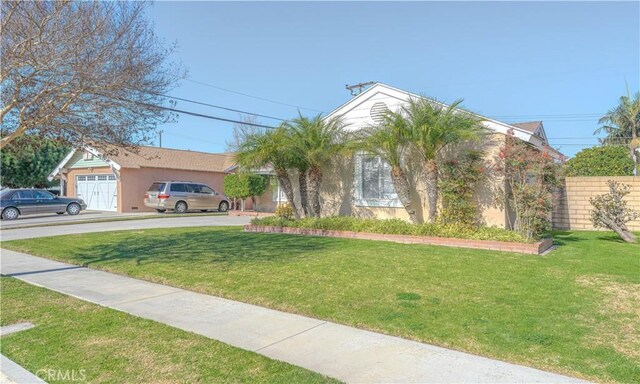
0;213;251;241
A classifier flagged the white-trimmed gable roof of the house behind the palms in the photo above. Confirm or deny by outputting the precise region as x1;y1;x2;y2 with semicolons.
325;83;561;158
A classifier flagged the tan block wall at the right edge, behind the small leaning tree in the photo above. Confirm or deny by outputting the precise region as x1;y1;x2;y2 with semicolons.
553;176;640;231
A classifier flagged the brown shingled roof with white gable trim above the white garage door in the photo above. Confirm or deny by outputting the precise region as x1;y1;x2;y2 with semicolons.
49;146;235;179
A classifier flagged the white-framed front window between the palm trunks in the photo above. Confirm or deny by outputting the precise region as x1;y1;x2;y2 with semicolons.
355;155;402;207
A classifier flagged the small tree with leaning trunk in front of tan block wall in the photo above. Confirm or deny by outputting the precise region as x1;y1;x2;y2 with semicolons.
589;180;640;243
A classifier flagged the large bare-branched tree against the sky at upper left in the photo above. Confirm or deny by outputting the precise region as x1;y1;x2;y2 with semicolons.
0;1;185;154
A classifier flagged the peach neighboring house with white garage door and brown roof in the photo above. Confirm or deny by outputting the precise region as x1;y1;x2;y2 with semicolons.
49;146;233;212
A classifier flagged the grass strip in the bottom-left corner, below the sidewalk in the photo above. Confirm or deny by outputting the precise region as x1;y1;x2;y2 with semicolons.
1;277;333;383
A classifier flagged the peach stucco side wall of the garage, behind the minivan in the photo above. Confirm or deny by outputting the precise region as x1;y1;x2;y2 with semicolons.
118;168;225;212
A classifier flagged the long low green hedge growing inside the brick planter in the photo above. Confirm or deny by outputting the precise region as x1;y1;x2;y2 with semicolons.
251;216;527;243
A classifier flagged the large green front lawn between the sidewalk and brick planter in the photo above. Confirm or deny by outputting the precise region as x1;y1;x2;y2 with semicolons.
2;227;640;382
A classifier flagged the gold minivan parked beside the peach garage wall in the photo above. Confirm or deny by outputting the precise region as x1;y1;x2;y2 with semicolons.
144;181;229;213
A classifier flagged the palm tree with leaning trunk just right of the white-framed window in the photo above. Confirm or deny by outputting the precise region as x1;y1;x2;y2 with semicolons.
358;111;420;224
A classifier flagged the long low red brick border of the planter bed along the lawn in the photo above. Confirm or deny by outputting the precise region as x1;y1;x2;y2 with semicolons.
244;224;553;255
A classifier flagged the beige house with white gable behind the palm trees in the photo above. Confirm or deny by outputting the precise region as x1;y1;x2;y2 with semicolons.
252;83;562;227
